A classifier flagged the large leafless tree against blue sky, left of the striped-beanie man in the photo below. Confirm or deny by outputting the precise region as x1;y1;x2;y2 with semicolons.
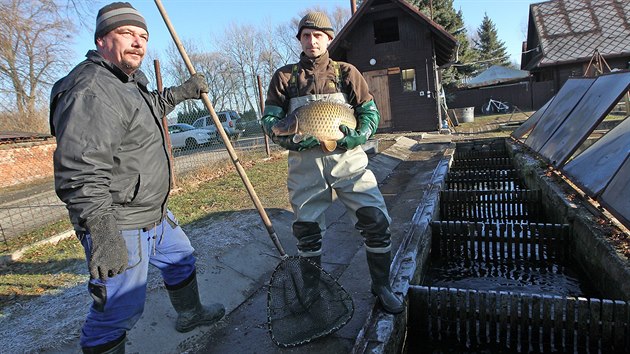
0;0;91;132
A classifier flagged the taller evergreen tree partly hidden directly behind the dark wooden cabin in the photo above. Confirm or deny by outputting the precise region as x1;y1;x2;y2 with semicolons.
408;0;477;88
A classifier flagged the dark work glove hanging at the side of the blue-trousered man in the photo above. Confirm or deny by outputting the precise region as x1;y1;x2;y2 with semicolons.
85;214;128;281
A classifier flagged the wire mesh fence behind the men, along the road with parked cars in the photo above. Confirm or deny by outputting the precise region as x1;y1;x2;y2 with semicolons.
0;117;278;253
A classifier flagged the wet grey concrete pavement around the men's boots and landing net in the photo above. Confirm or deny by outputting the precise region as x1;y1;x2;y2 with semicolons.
28;133;451;353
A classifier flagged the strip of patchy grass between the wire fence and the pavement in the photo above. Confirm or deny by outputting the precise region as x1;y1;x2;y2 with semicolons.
0;154;289;315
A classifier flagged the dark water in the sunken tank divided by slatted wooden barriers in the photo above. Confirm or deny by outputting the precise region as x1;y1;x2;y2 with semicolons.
404;146;612;353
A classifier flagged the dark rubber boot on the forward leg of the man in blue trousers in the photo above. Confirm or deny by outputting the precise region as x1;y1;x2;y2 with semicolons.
166;272;225;333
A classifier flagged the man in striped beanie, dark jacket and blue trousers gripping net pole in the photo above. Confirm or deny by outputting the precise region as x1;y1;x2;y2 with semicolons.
50;2;225;353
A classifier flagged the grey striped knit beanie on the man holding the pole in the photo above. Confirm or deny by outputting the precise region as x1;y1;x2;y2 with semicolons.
94;2;149;41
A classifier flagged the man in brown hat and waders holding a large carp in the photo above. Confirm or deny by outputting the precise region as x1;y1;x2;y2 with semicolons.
262;12;404;314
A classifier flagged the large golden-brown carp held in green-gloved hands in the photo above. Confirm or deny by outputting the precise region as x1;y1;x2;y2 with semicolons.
272;100;357;152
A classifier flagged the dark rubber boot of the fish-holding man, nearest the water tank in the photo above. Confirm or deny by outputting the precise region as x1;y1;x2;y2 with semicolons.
366;252;405;314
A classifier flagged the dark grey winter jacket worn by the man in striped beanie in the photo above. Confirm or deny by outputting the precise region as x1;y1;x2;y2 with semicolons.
50;51;179;231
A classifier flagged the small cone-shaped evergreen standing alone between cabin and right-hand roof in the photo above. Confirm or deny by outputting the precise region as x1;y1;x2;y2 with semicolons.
474;14;511;70
